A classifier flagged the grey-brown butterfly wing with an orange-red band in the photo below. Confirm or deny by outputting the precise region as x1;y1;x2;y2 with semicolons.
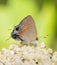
18;15;37;41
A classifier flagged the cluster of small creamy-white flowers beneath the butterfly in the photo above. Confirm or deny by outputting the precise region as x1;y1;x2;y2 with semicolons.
0;43;57;65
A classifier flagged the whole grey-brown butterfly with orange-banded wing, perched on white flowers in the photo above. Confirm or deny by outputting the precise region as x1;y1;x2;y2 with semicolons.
11;15;37;42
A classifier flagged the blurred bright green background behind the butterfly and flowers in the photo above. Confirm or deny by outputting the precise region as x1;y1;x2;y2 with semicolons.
0;0;57;51
